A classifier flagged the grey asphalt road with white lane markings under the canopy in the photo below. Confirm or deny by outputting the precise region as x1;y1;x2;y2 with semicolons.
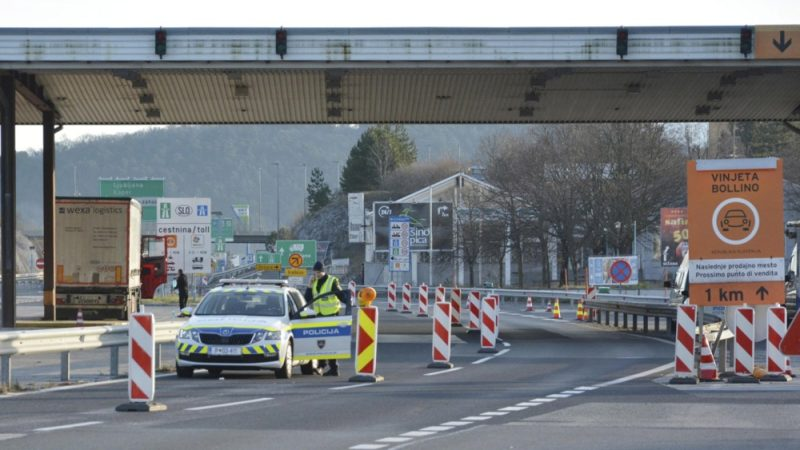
0;300;800;450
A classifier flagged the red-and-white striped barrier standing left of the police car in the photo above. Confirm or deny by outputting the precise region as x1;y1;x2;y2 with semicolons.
117;313;167;411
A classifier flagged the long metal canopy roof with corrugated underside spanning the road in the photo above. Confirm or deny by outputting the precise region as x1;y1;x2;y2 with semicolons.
0;27;800;124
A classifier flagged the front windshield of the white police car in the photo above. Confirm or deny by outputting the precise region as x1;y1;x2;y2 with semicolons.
195;289;286;317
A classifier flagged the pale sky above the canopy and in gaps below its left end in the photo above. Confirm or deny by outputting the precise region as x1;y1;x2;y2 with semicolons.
0;0;800;151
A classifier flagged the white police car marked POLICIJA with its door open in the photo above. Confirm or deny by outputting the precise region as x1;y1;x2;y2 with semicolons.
175;279;352;378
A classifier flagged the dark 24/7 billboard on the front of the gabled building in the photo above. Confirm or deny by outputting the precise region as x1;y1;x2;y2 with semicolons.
372;202;453;252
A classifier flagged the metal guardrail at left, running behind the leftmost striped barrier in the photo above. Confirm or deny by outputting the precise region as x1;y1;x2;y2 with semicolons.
0;320;184;388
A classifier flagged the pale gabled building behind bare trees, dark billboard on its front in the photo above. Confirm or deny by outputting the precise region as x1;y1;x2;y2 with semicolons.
364;170;541;286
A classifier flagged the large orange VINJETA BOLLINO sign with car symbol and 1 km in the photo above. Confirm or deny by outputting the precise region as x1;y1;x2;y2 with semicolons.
687;158;784;306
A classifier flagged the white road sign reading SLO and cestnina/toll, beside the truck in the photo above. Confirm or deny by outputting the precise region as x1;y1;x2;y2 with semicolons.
156;197;212;275
